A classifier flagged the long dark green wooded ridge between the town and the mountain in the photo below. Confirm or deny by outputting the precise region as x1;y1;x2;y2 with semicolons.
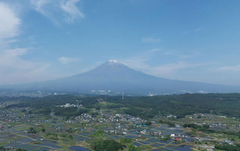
1;93;240;119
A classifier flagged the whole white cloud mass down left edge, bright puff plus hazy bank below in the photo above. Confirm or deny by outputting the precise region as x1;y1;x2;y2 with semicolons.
0;2;54;85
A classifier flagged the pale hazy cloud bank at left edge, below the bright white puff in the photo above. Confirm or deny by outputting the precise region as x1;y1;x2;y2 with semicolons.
0;48;55;84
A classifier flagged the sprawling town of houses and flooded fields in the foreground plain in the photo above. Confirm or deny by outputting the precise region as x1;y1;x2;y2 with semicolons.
0;94;240;151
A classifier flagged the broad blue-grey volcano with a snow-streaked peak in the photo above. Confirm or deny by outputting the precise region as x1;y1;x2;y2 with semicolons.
2;60;240;95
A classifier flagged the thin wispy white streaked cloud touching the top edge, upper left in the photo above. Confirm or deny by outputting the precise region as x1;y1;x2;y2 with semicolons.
31;0;84;24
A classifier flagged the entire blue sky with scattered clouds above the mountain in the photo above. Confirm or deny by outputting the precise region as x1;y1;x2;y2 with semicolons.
0;0;240;85
